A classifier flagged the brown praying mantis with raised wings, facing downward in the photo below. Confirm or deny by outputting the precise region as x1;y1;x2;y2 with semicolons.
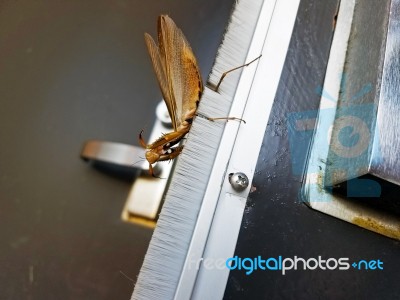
139;15;258;177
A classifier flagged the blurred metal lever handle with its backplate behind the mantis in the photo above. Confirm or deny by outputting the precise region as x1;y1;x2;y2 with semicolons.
81;101;173;227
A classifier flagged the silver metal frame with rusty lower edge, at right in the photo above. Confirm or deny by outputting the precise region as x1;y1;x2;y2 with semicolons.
302;0;400;240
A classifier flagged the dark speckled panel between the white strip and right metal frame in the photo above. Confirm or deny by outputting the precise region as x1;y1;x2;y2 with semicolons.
224;0;400;299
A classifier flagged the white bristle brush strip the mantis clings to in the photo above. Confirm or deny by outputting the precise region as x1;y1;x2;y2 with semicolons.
131;0;263;300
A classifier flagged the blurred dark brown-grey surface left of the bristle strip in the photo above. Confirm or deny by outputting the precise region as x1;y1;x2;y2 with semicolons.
0;0;233;300
